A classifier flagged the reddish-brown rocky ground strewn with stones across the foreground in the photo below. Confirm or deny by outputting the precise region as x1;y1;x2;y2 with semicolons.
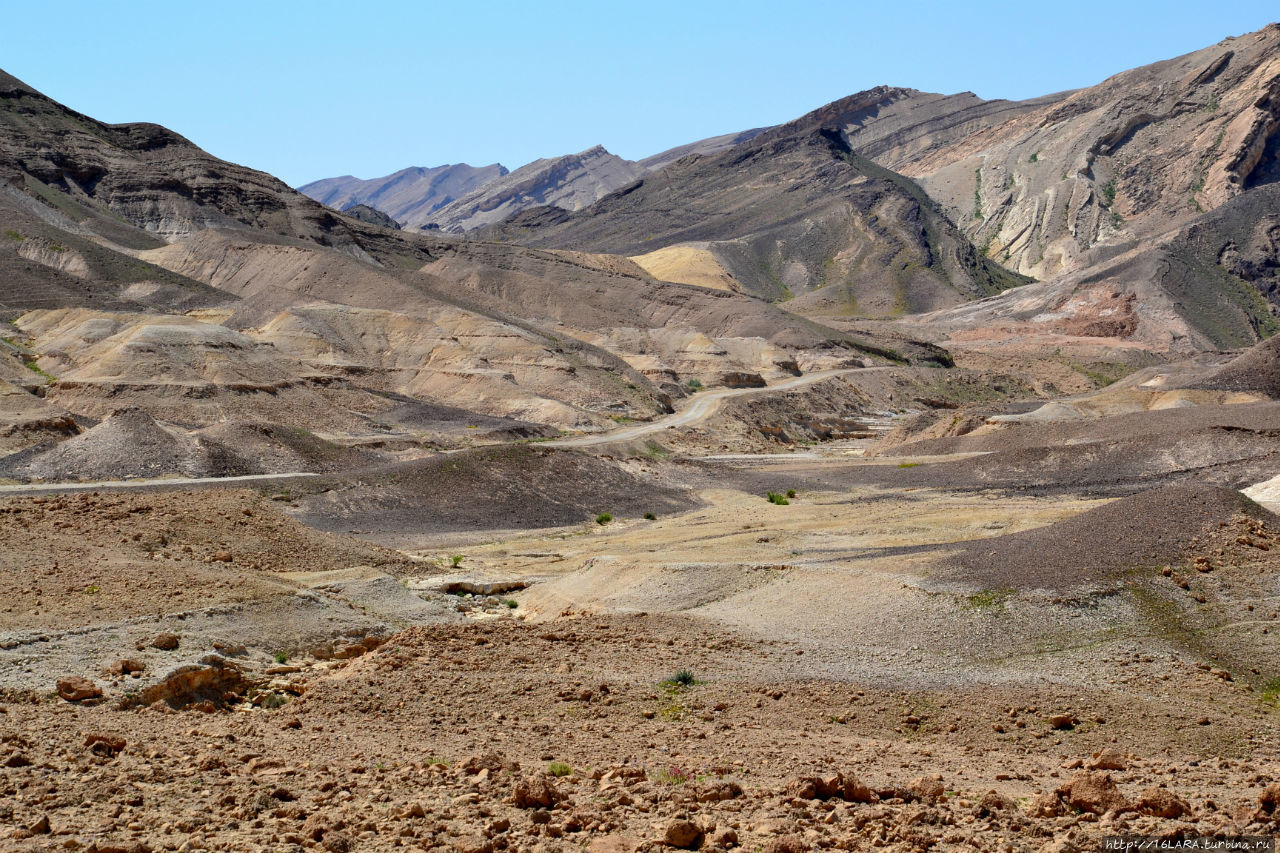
0;616;1280;852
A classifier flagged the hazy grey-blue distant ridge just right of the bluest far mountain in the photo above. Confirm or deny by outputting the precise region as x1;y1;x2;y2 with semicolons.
406;145;644;234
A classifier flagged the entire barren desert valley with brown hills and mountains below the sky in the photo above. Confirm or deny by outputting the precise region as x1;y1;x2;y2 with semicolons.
0;24;1280;853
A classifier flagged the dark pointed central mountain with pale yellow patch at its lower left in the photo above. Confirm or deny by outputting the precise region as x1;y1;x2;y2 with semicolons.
481;103;1027;316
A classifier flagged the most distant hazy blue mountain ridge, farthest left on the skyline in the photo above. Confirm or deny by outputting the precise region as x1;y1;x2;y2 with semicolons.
298;163;507;227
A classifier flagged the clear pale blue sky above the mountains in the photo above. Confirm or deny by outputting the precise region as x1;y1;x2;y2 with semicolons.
10;0;1280;184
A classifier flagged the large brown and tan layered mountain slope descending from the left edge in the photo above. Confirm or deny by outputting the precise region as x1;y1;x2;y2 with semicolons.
0;67;947;453
